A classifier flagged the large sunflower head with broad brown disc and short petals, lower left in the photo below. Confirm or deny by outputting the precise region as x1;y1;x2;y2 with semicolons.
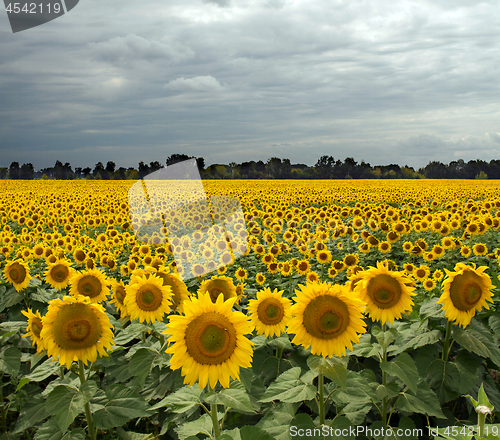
40;296;113;369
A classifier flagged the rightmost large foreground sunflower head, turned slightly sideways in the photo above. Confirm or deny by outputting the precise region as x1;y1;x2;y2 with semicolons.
437;263;494;328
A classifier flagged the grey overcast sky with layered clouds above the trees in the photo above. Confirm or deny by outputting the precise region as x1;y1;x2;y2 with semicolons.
0;0;500;169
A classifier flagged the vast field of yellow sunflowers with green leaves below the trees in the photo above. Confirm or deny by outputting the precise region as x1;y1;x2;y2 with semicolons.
0;180;500;440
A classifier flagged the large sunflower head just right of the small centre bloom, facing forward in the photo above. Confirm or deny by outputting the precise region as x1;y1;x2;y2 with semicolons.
287;282;366;358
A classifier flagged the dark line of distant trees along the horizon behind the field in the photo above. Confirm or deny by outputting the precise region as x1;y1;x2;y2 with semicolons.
0;154;500;180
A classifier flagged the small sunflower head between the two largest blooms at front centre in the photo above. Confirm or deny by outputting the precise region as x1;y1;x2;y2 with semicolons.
248;287;292;337
